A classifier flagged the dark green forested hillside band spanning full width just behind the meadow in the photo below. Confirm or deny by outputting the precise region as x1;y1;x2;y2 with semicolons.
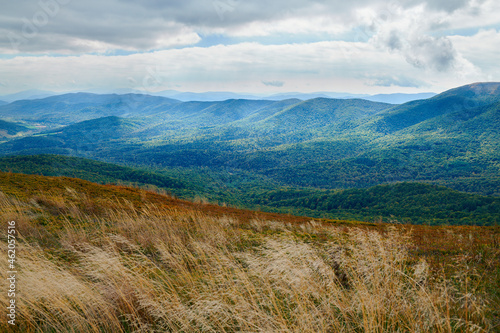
0;155;500;225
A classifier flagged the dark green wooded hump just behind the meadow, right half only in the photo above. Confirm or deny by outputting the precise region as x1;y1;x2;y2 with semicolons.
249;183;500;225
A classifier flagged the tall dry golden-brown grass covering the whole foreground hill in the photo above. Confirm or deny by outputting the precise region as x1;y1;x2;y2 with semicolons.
0;184;500;332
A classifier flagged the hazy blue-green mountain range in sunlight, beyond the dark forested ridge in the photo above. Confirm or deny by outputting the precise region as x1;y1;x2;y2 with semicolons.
0;83;500;223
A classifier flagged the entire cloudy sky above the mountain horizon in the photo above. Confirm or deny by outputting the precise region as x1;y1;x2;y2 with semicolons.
0;0;500;95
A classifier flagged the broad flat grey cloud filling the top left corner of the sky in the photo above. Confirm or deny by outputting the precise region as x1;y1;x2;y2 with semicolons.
0;0;203;53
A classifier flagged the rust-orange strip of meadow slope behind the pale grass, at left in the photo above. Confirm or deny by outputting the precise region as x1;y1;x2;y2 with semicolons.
0;171;320;223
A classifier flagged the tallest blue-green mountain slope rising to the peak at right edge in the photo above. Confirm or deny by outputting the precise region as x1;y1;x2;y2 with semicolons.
258;84;500;195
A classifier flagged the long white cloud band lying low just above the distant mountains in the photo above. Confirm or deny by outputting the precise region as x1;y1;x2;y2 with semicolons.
0;42;480;93
